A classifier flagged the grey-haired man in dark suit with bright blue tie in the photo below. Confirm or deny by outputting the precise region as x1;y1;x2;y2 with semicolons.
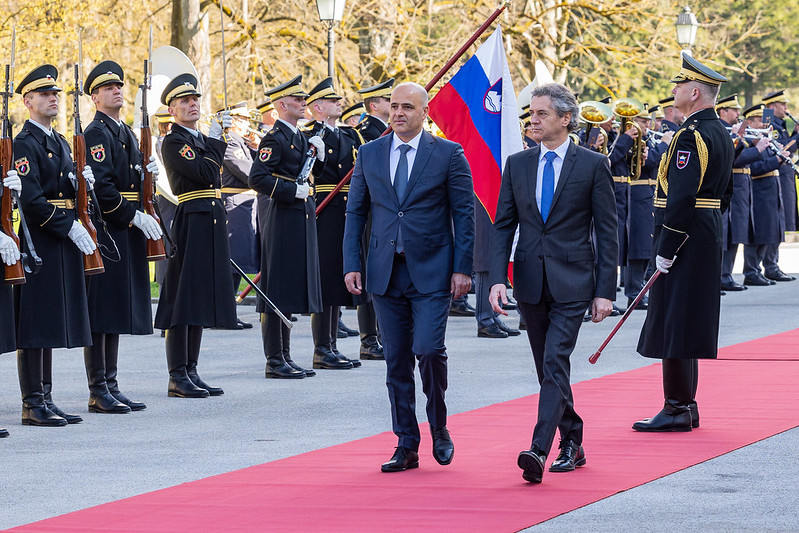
489;83;618;483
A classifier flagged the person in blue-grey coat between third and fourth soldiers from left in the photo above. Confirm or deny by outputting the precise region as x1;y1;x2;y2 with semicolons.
213;102;259;329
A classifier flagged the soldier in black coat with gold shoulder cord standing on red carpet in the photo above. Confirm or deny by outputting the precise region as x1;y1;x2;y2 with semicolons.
633;54;734;431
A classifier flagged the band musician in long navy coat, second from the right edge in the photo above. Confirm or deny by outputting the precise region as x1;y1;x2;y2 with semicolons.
744;104;785;287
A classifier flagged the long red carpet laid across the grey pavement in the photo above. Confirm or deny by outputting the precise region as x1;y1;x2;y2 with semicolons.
12;331;799;532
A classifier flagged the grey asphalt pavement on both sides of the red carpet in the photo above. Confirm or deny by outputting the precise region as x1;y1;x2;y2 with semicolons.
0;244;799;533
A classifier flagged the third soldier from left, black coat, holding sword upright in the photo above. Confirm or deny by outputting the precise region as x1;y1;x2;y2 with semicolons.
155;74;236;398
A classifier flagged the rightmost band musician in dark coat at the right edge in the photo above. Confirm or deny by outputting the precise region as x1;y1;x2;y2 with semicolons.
763;90;799;281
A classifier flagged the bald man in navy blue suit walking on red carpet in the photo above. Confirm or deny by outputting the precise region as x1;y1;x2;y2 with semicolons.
344;83;474;472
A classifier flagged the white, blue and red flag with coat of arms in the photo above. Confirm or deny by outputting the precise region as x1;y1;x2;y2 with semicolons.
430;27;523;223
